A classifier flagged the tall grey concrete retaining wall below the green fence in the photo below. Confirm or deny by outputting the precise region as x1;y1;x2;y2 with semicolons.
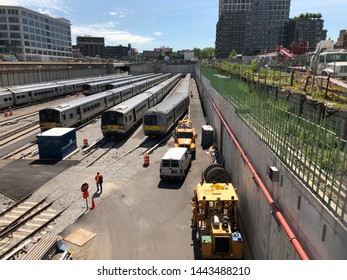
195;66;347;260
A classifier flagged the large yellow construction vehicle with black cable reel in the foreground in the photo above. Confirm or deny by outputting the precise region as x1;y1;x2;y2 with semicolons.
192;164;243;259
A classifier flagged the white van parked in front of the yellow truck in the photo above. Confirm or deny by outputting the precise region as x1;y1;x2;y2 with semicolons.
160;147;192;180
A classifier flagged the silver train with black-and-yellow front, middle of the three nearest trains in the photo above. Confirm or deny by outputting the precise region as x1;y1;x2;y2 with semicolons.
101;74;181;137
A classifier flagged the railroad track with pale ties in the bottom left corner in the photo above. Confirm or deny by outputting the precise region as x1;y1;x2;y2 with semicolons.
0;195;67;260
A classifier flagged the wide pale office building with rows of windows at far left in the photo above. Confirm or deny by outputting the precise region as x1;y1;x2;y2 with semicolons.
0;6;72;61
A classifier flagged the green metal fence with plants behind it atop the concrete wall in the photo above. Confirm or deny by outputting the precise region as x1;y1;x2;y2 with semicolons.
201;64;347;225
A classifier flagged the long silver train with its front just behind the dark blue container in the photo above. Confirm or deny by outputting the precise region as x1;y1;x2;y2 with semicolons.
39;73;171;131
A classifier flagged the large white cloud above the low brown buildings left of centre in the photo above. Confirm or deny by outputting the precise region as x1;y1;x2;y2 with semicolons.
71;21;154;46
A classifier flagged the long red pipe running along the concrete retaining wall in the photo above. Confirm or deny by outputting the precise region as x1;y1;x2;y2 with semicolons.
206;87;309;260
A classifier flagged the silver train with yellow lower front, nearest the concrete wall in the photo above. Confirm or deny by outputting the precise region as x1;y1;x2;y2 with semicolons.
142;74;190;137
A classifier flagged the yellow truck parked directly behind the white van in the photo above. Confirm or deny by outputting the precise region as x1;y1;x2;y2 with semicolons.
173;119;197;159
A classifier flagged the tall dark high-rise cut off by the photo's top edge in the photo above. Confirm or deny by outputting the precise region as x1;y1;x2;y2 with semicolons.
215;0;290;58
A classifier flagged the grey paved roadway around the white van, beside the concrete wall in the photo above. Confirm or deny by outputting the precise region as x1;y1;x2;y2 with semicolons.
62;77;209;260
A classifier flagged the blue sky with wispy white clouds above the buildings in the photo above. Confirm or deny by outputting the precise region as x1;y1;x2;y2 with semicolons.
0;0;347;52
